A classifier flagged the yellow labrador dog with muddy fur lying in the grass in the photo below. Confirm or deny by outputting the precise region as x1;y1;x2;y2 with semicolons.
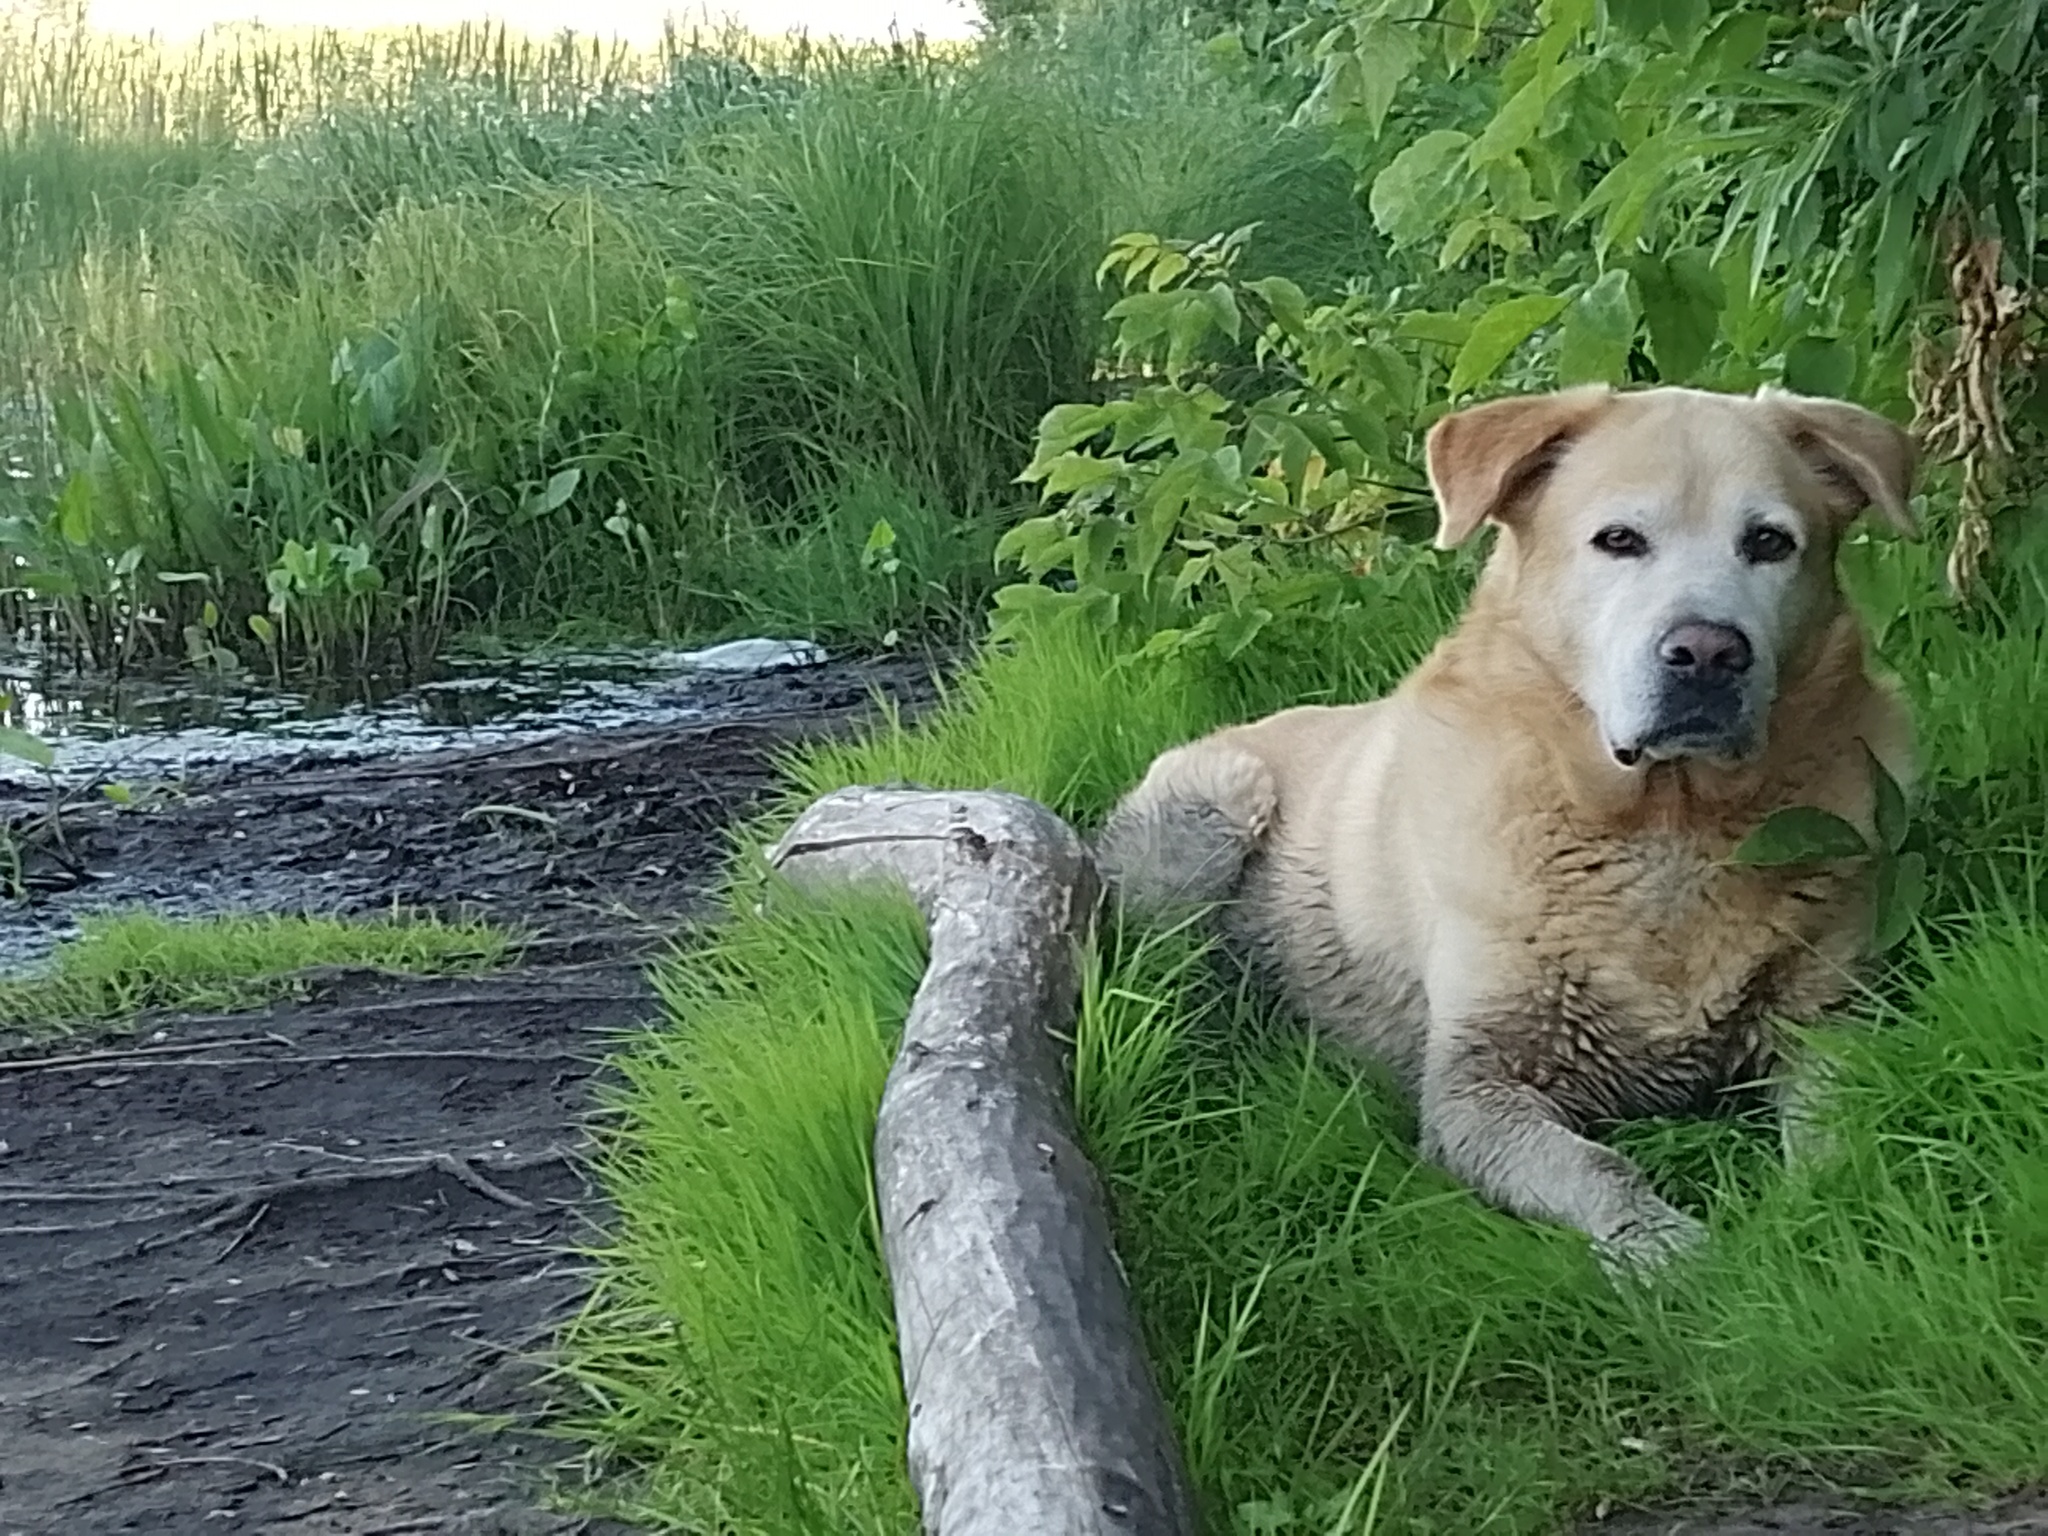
1098;387;1913;1262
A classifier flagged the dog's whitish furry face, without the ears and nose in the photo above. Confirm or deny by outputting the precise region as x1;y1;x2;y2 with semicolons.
1509;391;1835;766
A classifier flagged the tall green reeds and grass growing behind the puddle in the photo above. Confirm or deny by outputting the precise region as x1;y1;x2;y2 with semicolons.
0;0;1366;670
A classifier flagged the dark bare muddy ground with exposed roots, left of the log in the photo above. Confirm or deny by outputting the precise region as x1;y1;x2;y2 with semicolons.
0;655;937;1536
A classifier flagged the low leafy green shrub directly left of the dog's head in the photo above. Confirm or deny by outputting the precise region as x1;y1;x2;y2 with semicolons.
995;229;1427;655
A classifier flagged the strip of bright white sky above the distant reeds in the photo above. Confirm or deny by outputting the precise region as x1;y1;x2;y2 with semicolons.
90;0;979;43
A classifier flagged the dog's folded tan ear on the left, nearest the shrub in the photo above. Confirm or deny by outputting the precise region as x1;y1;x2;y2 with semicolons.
1427;385;1614;549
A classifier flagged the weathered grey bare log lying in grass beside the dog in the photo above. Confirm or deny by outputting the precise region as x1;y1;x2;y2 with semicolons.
770;788;1194;1536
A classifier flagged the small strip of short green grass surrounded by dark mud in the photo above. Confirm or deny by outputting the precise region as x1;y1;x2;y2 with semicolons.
0;911;518;1040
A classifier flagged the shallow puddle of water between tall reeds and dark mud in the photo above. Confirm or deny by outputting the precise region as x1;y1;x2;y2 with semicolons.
0;641;825;793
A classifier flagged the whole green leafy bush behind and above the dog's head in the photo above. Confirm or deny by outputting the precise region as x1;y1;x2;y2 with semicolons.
997;0;2048;649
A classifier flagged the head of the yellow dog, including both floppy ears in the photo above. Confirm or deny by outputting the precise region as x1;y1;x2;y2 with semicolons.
1430;387;1913;768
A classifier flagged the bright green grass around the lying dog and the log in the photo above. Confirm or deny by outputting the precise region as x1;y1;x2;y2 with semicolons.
563;543;2048;1536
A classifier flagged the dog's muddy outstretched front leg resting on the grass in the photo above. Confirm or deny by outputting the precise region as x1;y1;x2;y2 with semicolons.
1421;1038;1706;1268
